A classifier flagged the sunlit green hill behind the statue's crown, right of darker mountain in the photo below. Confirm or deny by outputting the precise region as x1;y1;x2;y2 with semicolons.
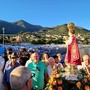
35;24;90;35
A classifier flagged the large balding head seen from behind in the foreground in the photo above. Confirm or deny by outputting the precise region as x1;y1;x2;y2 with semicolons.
10;66;32;90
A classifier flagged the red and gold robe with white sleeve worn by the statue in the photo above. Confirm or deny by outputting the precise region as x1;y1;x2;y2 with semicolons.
65;35;81;65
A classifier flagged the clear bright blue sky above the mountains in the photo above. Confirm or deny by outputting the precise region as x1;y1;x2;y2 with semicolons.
0;0;90;30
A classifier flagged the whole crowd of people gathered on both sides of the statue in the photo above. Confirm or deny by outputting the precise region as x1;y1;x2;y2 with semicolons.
0;48;90;90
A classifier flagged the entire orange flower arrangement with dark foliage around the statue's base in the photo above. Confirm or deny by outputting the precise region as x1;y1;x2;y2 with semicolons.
44;65;90;90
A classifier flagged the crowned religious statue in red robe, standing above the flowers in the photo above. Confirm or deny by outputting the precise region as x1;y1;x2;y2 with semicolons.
65;23;81;66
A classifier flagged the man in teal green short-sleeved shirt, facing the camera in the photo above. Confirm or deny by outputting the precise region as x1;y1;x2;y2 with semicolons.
27;52;48;90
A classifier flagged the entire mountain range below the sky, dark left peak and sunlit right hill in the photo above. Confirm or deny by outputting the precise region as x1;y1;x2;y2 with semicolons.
0;20;90;35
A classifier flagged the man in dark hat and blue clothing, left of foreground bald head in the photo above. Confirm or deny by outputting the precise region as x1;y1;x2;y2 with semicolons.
3;52;20;90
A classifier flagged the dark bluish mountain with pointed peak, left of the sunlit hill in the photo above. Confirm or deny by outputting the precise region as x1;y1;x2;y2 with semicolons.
0;20;43;34
